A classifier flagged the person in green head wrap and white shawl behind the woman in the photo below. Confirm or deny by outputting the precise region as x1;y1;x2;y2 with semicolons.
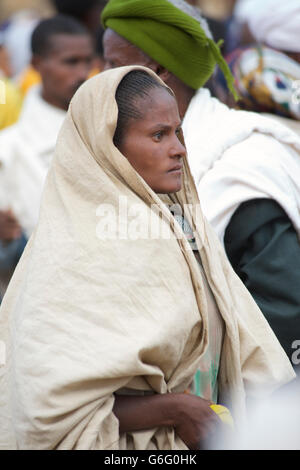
102;0;300;368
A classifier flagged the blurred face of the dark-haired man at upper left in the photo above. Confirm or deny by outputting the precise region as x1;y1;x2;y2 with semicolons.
33;34;94;110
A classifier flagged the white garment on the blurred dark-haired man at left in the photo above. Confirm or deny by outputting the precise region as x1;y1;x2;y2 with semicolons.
0;86;66;237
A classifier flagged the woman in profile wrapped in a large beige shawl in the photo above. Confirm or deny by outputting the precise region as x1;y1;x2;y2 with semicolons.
0;66;294;449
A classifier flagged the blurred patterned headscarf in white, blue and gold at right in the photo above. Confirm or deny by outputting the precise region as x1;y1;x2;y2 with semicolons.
216;45;300;119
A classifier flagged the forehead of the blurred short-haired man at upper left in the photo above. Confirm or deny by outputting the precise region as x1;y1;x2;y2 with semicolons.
47;34;93;57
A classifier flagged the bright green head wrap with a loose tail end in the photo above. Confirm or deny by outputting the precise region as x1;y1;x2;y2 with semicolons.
102;0;237;98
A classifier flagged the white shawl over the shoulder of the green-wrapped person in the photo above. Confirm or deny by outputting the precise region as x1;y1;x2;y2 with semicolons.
183;89;300;241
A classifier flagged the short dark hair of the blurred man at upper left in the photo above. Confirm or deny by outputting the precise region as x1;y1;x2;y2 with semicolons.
31;15;89;55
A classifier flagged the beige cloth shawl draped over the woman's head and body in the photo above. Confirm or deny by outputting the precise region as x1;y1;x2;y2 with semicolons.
0;67;294;449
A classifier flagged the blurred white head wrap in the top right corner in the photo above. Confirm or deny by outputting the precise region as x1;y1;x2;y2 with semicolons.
235;0;300;52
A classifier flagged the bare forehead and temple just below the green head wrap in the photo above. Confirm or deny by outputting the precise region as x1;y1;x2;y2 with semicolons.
103;29;148;66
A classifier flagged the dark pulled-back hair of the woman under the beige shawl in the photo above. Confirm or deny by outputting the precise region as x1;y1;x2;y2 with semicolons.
113;70;172;147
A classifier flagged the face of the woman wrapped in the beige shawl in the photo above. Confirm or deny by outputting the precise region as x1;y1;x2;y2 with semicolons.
119;88;186;194
